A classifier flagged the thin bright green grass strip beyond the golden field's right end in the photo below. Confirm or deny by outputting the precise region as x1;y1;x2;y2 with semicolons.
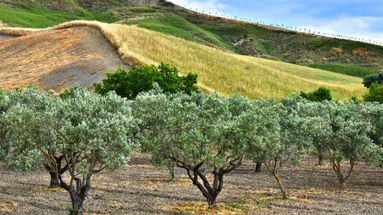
305;64;378;78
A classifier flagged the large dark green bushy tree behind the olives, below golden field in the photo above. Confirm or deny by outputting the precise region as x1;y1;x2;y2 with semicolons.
94;63;198;99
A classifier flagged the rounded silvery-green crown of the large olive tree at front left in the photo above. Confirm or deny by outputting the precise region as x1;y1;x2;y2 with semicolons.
54;88;136;174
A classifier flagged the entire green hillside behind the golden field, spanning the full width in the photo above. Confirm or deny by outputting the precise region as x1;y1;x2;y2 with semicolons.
0;0;383;77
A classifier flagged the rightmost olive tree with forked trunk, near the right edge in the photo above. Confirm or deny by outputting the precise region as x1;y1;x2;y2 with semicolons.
308;102;381;189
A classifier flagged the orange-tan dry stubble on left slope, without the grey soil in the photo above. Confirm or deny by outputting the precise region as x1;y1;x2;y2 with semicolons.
0;28;103;90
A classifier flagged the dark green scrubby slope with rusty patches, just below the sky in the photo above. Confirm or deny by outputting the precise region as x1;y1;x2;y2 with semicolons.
136;7;383;77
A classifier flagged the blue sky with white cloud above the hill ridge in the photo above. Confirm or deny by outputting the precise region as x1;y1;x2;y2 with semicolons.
170;0;383;42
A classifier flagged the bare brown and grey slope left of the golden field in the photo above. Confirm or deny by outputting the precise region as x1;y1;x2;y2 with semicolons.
0;27;132;90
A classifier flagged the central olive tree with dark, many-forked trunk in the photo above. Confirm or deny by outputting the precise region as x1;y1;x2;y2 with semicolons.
135;93;248;207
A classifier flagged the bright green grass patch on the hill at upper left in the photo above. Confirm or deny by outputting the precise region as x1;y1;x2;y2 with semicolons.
0;3;117;28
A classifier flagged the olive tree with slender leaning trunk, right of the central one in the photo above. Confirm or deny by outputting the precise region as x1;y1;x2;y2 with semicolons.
239;99;311;198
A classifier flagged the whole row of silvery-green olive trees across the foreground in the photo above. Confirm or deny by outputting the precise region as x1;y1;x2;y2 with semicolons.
0;85;383;214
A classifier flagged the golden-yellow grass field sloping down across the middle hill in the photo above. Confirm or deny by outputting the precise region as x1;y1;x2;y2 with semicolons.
0;21;365;99
